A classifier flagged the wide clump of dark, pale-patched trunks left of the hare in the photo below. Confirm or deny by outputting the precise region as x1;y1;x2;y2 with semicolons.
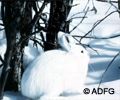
0;0;32;100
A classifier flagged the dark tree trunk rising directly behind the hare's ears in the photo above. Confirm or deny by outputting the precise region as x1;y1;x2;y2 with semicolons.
44;0;73;51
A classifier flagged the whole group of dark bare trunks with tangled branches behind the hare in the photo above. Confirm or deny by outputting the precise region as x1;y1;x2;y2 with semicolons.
0;0;73;100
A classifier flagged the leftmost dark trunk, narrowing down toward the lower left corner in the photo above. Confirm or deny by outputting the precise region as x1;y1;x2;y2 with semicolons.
0;2;18;98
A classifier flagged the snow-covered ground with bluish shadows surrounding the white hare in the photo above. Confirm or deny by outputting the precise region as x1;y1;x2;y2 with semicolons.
0;0;120;100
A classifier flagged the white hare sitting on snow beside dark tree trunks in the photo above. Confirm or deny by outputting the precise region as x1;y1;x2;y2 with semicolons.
21;32;89;100
